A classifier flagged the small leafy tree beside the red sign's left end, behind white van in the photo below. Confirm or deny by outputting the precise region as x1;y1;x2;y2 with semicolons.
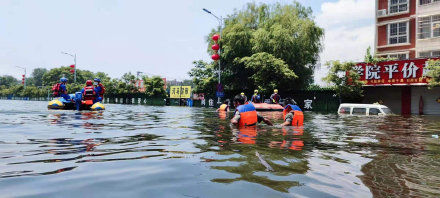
323;61;364;101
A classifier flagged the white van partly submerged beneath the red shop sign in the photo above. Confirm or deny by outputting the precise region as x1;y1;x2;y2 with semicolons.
338;103;393;116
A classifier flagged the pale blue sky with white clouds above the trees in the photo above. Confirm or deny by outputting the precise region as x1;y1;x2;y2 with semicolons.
0;0;375;84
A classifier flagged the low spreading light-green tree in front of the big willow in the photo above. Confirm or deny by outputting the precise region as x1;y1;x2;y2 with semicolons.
239;52;298;95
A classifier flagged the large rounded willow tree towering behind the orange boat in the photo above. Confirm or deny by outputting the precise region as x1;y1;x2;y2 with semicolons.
196;2;324;96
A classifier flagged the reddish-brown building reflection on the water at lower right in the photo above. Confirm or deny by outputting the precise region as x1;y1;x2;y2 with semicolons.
361;117;440;197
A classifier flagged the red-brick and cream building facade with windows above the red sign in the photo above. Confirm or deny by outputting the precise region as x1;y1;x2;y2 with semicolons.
375;0;440;60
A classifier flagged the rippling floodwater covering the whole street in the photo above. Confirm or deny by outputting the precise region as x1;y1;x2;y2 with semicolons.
0;100;440;198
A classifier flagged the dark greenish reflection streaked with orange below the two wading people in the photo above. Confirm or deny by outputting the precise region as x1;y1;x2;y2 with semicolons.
194;112;309;192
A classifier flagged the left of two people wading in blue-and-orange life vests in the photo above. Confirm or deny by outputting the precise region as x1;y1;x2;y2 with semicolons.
231;95;273;127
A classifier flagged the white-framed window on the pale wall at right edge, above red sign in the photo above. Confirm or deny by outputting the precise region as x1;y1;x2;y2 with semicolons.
418;14;440;39
